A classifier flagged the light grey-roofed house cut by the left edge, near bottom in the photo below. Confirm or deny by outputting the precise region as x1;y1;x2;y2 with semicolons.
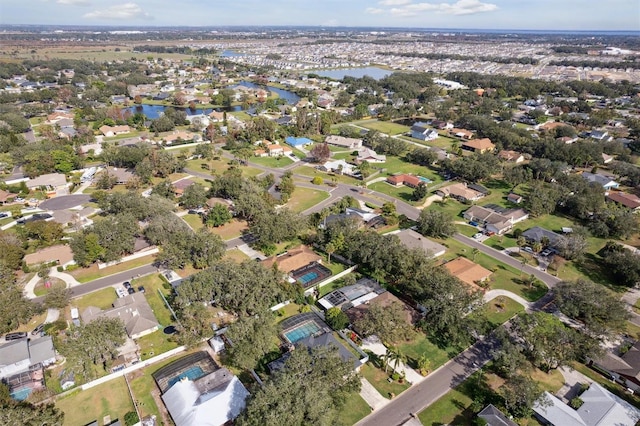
0;336;56;379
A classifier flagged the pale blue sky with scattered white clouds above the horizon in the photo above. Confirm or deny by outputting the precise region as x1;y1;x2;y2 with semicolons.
0;0;640;30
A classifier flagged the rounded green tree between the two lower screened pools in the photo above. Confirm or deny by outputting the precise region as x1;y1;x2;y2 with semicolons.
226;311;277;370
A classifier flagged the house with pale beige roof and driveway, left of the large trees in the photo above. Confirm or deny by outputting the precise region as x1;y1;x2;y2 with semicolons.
81;293;160;339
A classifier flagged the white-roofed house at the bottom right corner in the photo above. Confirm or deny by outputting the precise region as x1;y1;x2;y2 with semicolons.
533;383;640;426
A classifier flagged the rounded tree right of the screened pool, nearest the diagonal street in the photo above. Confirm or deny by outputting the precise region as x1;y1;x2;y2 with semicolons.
354;302;415;343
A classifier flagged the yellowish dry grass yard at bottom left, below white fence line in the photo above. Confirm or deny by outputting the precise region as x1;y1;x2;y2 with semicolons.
56;377;135;426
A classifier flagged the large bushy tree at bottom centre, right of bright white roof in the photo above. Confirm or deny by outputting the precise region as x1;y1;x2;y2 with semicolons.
236;347;360;426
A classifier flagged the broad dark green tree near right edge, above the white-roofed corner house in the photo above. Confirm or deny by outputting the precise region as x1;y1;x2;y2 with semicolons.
553;279;629;337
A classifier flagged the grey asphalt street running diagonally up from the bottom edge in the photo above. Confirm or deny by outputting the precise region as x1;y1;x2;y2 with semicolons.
356;337;497;426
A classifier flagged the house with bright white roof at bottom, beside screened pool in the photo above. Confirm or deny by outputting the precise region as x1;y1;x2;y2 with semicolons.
162;367;249;426
